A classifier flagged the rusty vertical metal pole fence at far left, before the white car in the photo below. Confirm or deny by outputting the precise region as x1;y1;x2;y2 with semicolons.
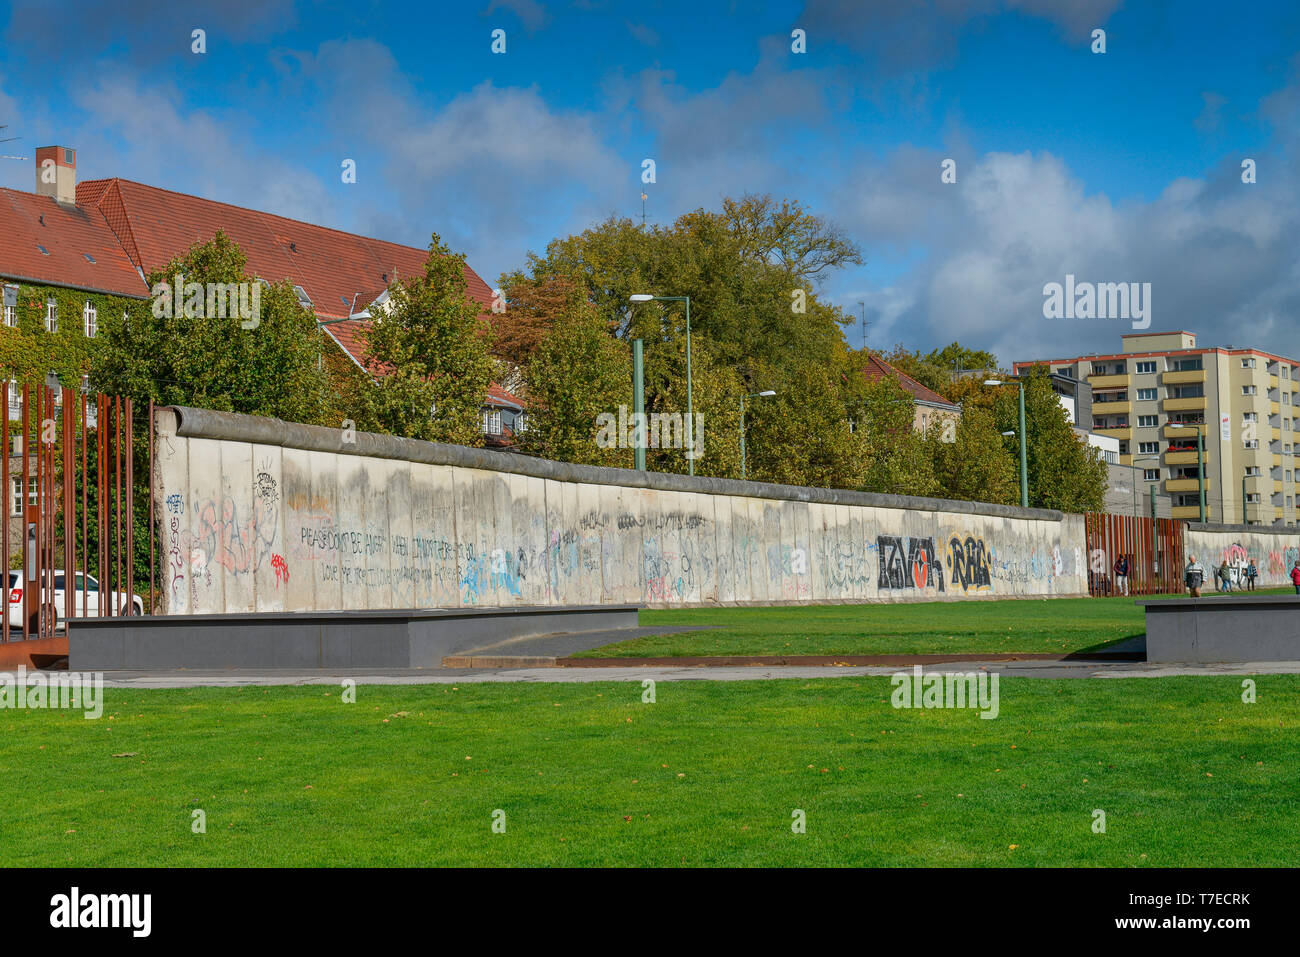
0;382;139;642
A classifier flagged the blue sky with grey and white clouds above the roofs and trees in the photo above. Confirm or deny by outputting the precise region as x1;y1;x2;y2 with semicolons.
0;0;1300;363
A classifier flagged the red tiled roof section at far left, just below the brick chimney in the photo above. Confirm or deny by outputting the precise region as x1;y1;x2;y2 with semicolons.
0;189;148;298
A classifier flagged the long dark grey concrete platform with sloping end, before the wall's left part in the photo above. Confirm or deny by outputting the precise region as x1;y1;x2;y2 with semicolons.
68;605;640;671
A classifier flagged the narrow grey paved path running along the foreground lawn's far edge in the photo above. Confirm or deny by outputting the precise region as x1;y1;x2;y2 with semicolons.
89;662;1300;688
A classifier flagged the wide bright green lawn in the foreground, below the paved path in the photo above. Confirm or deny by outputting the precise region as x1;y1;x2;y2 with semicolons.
0;676;1300;867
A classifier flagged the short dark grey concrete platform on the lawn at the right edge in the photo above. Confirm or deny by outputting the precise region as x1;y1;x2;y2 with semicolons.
1135;594;1300;662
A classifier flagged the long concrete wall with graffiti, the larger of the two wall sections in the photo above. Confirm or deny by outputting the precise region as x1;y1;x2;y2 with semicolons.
153;408;1087;614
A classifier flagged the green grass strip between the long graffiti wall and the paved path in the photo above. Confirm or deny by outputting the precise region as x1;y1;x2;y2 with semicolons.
576;589;1291;658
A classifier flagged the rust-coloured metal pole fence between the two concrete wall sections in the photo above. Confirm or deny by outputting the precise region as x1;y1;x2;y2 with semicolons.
1083;512;1184;597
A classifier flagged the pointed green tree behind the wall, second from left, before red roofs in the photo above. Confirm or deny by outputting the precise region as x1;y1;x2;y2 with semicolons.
361;234;497;446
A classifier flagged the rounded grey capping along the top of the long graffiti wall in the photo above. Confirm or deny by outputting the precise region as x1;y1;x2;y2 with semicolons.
156;406;1065;521
